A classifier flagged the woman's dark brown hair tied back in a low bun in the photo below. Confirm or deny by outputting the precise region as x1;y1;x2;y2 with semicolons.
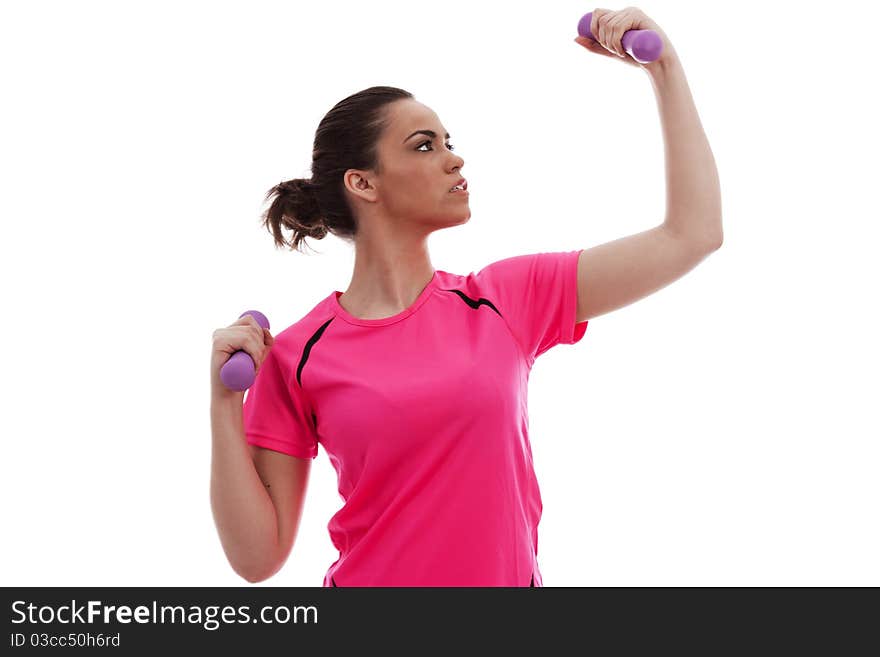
262;87;413;251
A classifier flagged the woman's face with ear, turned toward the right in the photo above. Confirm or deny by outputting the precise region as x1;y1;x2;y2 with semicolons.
346;99;471;230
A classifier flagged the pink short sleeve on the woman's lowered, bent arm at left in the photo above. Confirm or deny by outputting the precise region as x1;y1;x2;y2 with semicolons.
242;342;318;459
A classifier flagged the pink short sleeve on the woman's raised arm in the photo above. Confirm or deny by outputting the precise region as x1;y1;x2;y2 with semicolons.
474;249;588;363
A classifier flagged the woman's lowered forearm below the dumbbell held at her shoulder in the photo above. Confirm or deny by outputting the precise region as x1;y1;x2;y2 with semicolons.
211;396;278;582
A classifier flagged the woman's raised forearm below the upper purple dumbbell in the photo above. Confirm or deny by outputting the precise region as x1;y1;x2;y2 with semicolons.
645;52;723;245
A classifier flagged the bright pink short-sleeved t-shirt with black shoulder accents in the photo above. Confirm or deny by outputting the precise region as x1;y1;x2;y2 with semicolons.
243;250;587;586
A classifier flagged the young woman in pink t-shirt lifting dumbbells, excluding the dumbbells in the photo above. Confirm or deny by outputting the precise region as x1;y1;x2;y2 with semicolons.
211;8;722;586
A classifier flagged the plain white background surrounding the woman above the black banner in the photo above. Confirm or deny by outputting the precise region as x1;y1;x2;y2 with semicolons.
0;0;880;587
